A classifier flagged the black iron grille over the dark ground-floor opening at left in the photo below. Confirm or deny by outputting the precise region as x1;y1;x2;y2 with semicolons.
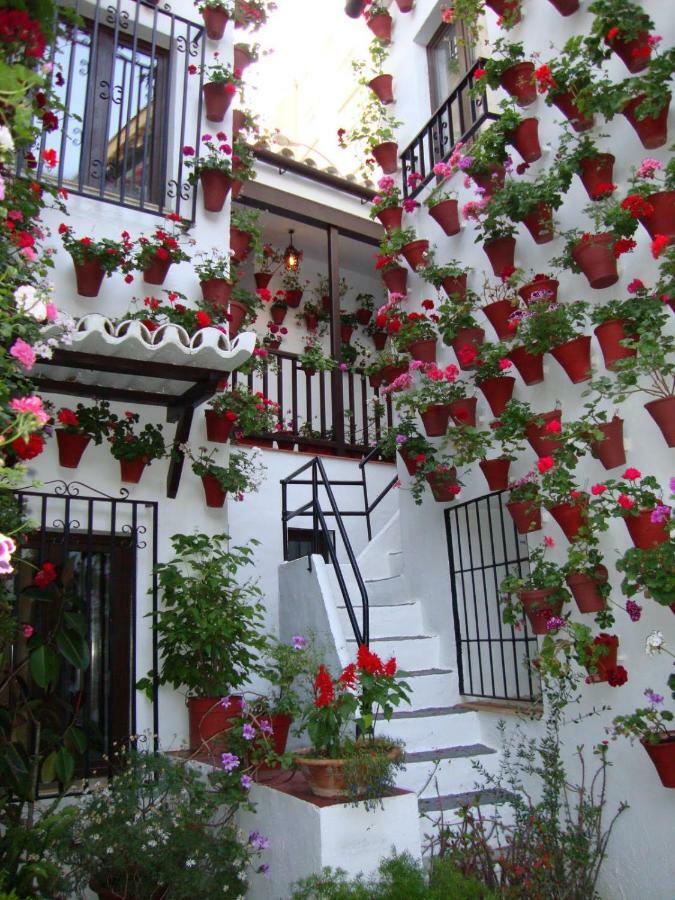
12;481;159;777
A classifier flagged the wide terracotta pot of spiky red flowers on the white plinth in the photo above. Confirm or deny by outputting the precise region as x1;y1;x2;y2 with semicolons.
295;644;409;802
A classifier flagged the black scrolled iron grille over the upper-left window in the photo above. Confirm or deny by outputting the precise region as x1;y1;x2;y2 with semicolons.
31;0;205;221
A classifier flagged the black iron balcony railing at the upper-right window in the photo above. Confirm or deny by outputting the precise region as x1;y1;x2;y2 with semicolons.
401;59;499;197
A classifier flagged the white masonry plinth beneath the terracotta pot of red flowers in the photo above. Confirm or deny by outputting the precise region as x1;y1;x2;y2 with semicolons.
238;784;421;900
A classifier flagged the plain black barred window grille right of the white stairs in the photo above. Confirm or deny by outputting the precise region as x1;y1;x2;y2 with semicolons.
445;492;540;701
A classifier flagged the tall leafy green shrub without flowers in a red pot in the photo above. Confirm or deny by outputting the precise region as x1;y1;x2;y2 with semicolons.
139;532;266;750
